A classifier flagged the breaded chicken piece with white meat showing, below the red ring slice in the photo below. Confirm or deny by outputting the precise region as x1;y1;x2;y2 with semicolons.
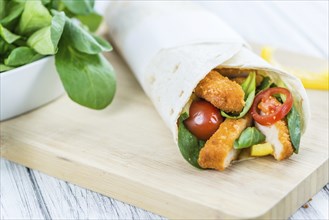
255;120;294;160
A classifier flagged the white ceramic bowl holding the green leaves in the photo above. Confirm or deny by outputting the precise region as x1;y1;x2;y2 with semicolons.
0;56;64;121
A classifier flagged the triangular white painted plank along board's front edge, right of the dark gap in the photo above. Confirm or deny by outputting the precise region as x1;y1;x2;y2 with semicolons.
33;166;161;219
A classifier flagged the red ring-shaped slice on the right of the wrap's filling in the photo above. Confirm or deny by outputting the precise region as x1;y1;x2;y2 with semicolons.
251;87;293;125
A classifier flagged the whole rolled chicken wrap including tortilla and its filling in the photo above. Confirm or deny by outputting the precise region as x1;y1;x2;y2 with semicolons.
105;1;309;170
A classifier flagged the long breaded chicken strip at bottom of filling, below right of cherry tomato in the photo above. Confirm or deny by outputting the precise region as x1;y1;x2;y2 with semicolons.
198;114;251;170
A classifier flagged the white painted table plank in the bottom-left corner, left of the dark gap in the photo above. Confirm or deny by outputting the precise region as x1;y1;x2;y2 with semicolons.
0;158;44;219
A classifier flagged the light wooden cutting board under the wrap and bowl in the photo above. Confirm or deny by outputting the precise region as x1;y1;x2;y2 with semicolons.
1;49;328;219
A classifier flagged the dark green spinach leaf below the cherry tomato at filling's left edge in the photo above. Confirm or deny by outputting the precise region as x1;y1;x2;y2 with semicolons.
178;112;205;169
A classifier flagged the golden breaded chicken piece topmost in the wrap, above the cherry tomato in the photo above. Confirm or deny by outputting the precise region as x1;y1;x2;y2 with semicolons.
195;71;245;113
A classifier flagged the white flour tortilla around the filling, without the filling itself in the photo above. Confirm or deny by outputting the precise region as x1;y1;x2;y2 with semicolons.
105;1;310;168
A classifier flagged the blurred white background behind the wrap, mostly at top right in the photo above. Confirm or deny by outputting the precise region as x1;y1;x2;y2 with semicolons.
96;0;329;58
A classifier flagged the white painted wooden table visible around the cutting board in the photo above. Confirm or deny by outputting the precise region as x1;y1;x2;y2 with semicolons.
0;0;329;219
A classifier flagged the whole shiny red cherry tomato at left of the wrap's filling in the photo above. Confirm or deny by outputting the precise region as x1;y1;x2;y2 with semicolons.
184;101;223;140
